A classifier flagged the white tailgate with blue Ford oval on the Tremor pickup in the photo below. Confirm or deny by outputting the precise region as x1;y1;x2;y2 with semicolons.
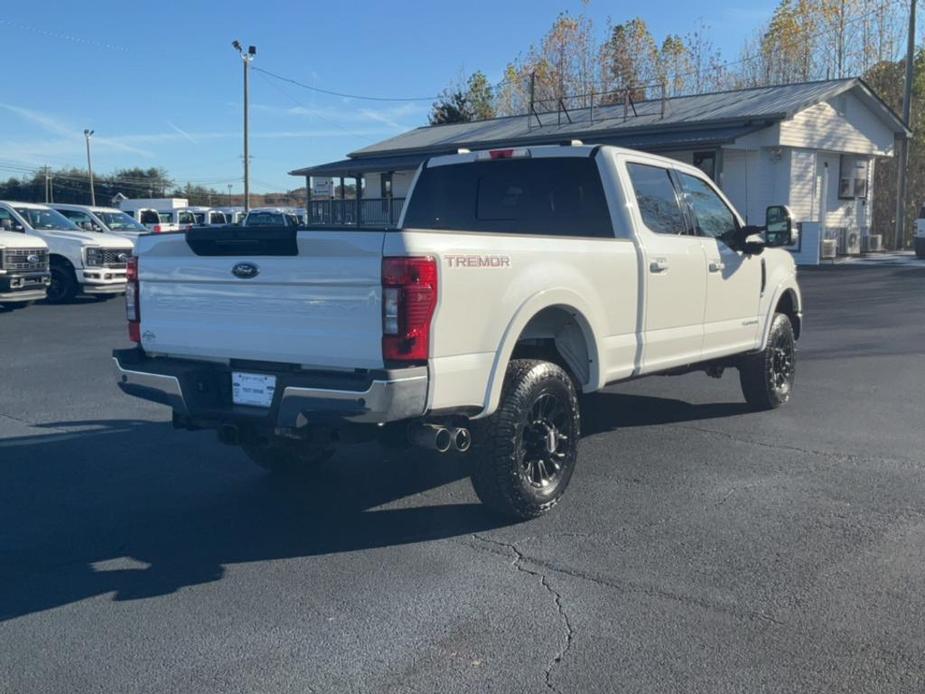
138;229;384;368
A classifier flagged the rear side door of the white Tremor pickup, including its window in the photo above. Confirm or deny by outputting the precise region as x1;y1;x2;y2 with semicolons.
626;162;706;373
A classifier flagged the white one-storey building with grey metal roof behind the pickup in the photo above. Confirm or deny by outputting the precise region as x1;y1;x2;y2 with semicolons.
291;78;911;262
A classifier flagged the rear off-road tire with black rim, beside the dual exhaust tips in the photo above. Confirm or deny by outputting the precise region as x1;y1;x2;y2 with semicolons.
472;359;581;520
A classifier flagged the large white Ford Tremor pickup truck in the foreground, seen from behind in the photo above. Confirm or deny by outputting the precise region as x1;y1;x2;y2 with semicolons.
114;143;802;518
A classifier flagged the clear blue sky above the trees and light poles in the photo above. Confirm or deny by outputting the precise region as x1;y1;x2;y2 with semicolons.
0;0;775;192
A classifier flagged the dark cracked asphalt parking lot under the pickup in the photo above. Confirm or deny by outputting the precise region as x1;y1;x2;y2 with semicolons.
0;267;925;693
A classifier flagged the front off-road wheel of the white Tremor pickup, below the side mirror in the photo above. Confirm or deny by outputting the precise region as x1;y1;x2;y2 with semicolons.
739;313;796;410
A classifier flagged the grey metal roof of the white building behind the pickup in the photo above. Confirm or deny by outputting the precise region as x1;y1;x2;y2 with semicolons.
291;77;911;176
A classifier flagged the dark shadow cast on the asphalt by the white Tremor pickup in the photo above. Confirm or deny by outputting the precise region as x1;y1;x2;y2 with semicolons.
0;392;747;621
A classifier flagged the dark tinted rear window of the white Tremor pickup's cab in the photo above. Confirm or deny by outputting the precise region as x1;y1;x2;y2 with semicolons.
405;157;613;238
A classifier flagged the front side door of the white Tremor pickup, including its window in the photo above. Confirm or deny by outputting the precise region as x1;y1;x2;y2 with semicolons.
678;172;762;359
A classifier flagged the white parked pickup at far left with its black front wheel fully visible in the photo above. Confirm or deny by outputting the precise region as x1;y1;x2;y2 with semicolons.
0;200;133;303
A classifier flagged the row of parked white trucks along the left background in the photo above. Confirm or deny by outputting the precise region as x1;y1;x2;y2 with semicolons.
0;200;305;308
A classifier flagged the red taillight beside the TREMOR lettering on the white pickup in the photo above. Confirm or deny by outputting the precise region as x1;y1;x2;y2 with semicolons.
382;257;437;361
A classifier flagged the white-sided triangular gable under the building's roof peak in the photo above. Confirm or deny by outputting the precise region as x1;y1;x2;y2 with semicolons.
779;94;894;155
